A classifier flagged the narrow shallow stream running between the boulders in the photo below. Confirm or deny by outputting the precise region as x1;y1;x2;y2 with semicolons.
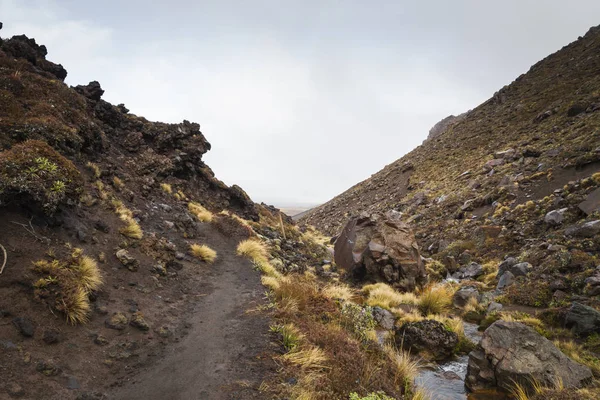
416;322;507;400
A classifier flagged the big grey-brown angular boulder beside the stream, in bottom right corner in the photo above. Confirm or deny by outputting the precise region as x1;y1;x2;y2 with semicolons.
465;321;592;390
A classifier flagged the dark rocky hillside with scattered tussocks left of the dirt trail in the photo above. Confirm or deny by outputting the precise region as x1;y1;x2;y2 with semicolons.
0;28;269;399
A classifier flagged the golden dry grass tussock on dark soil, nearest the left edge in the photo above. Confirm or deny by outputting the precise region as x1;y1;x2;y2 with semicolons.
33;249;103;324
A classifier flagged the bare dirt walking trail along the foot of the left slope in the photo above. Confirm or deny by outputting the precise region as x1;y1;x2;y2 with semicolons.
108;233;274;400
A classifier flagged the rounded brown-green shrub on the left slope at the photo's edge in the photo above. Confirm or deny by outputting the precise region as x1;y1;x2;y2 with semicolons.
0;140;82;214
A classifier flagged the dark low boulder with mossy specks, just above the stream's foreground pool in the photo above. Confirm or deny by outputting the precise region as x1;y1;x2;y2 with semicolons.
394;319;458;360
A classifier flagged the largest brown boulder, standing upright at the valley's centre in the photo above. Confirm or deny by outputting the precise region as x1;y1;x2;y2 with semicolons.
335;211;426;290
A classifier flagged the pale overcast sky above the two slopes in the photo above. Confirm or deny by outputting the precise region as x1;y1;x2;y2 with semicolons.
0;0;600;206
